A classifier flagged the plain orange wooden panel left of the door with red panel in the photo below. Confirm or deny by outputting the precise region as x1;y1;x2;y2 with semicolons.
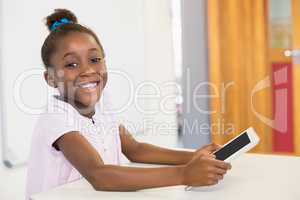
208;0;272;153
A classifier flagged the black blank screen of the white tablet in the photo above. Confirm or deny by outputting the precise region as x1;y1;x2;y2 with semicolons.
214;132;250;160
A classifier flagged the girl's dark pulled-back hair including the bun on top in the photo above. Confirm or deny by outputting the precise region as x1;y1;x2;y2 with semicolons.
41;9;104;68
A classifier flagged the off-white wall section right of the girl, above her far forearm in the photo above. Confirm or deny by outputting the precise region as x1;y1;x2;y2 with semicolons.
134;0;177;147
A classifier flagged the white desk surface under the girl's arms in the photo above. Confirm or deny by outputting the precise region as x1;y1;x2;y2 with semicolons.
32;154;300;200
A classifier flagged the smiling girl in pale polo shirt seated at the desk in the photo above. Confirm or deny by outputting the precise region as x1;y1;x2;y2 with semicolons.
26;9;231;199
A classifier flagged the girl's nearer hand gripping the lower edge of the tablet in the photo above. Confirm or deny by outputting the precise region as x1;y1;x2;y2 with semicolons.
182;151;231;186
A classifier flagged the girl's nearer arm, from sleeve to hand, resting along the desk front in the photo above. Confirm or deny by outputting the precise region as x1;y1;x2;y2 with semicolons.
54;132;230;191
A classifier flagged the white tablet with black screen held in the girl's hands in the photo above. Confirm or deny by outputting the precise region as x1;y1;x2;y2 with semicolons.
213;127;259;162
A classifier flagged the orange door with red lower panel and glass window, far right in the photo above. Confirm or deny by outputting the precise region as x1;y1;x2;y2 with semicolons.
268;0;300;155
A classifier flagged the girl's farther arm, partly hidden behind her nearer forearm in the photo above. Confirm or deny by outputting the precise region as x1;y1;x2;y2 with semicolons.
119;125;219;165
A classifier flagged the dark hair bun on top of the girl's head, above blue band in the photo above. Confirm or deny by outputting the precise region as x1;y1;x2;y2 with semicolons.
46;9;78;31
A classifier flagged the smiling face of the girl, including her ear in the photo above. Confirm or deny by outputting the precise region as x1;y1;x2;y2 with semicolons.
47;33;107;115
